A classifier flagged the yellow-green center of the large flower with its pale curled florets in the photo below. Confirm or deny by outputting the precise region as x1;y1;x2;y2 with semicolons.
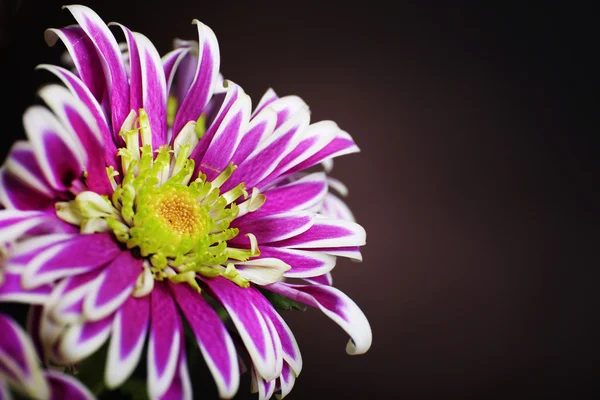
56;109;265;290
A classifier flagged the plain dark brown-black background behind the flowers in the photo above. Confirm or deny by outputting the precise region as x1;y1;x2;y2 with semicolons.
0;0;600;399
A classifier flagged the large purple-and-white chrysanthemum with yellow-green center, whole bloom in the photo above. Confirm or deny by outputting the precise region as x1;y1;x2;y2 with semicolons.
0;6;371;398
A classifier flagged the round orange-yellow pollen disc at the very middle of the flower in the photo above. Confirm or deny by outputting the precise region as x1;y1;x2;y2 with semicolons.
156;194;201;236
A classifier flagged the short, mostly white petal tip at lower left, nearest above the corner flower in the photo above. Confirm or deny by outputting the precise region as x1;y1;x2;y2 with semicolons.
57;314;114;363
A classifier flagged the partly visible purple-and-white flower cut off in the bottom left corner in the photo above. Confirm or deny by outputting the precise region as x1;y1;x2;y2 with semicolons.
0;314;93;400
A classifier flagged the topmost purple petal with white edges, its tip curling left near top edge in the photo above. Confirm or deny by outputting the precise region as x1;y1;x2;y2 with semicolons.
65;5;130;136
